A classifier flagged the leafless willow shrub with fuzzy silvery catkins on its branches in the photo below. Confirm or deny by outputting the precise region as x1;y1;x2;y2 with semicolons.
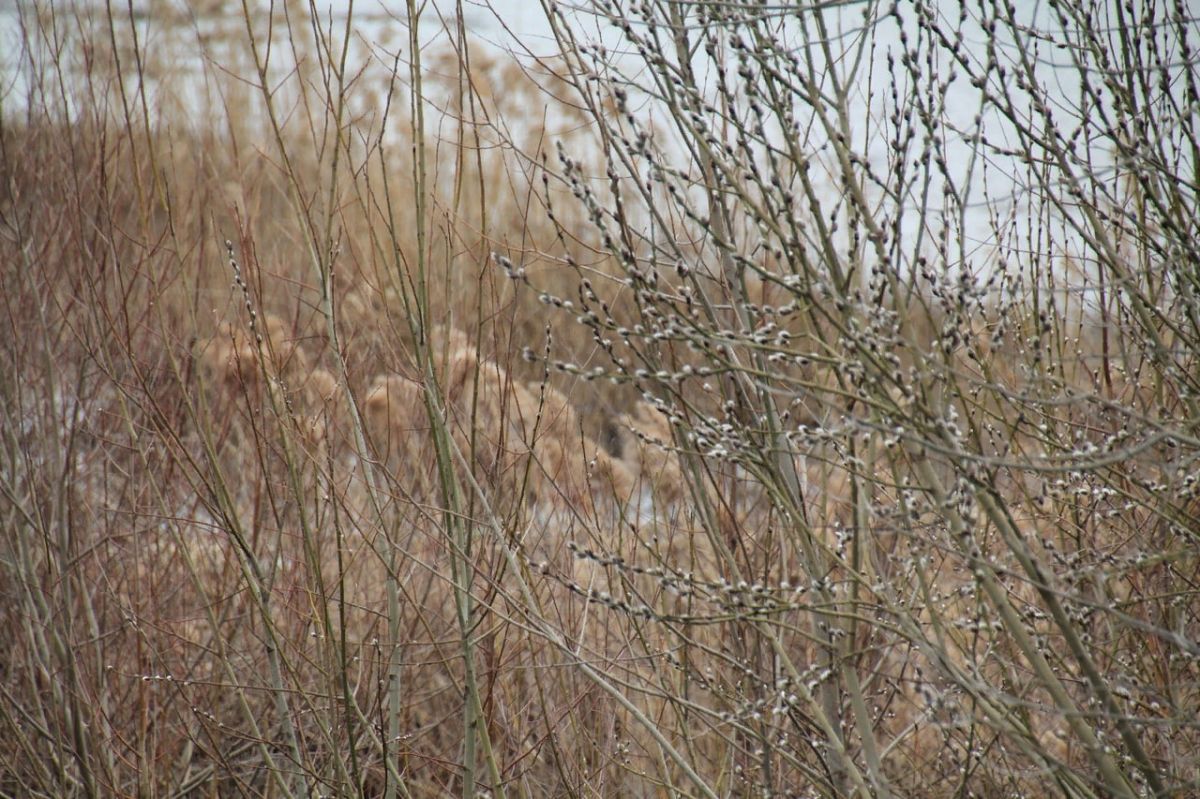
498;2;1198;795
